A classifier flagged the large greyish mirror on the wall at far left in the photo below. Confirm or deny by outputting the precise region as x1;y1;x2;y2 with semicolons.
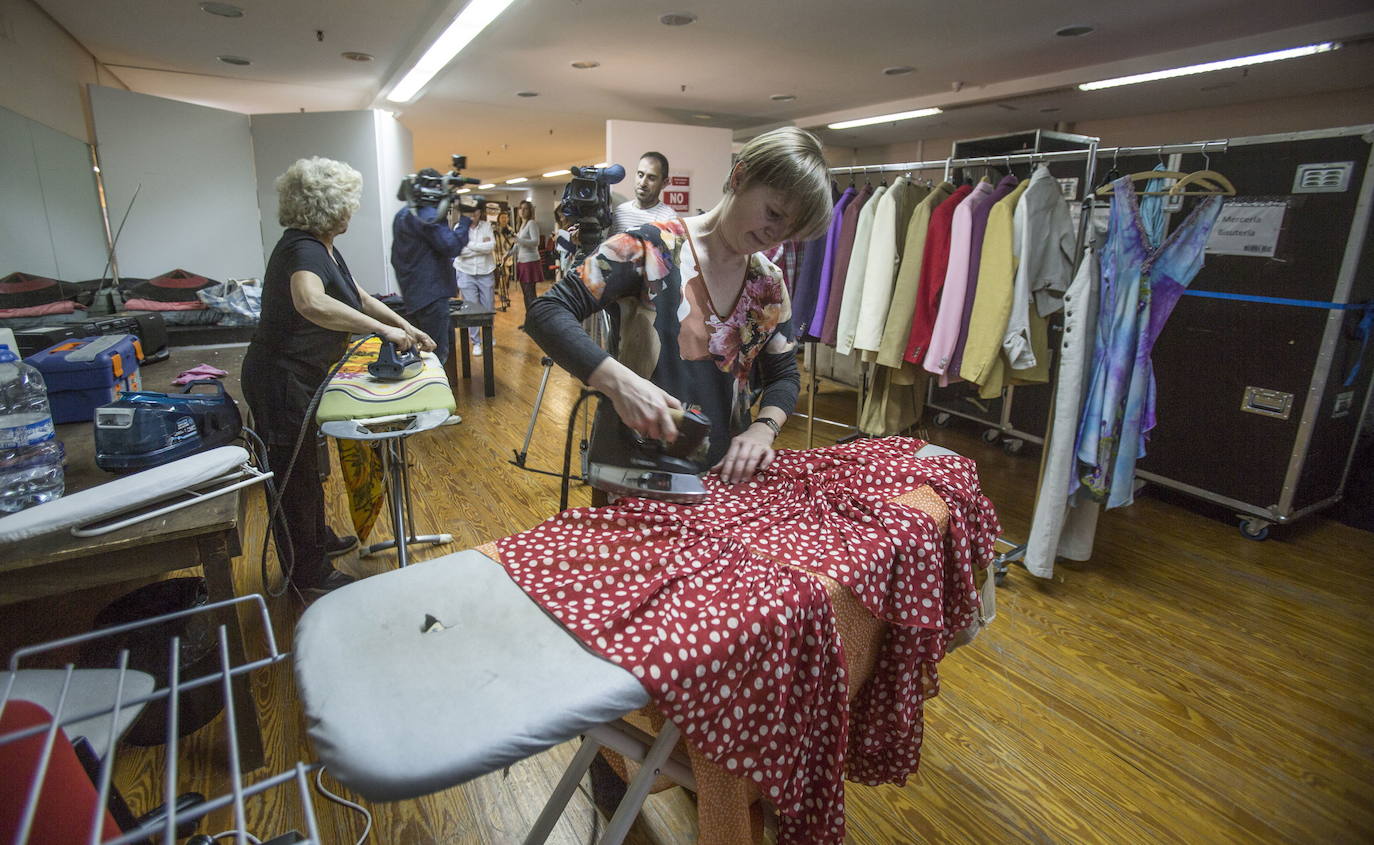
0;109;109;282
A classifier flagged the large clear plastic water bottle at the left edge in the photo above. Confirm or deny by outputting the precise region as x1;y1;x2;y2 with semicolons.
0;346;63;512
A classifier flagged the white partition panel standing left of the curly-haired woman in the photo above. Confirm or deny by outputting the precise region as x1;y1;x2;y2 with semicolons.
89;85;264;280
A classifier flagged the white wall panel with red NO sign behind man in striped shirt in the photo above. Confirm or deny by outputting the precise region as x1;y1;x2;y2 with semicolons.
606;121;732;212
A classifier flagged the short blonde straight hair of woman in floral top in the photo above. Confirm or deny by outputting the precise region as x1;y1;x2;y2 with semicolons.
725;126;833;240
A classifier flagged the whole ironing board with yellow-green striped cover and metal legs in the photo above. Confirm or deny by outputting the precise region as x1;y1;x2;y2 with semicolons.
315;338;456;567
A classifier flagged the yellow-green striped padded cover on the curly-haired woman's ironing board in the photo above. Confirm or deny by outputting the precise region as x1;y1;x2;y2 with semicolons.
315;338;458;422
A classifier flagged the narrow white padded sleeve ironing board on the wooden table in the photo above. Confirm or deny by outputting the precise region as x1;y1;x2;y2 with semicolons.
0;447;249;548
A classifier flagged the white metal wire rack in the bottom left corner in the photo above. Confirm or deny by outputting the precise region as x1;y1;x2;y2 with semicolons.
0;595;322;845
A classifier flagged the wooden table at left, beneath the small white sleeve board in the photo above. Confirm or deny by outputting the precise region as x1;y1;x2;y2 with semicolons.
0;423;264;772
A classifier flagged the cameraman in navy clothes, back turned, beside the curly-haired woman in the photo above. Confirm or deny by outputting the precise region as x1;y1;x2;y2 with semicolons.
392;168;471;361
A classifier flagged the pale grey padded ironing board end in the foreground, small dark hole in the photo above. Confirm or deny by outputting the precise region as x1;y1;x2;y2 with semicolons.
294;550;649;801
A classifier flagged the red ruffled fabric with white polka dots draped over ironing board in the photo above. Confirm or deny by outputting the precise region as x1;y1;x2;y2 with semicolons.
499;437;1000;844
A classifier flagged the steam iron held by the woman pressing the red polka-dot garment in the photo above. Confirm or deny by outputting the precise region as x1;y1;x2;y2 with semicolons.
587;403;710;504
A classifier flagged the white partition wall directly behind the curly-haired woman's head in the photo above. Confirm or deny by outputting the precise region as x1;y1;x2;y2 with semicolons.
253;111;409;293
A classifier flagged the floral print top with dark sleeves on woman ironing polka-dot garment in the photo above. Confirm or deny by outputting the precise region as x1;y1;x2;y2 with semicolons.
525;220;801;463
